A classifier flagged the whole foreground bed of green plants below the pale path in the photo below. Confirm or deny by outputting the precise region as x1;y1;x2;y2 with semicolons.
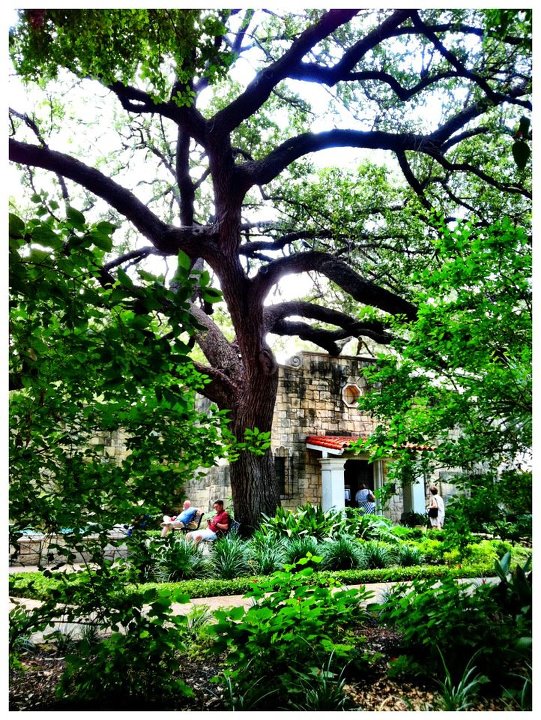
12;555;531;710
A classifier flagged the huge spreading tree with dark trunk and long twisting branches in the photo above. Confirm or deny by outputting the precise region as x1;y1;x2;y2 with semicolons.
10;10;531;526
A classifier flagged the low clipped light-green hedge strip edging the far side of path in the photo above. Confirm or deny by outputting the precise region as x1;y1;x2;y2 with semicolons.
9;565;494;600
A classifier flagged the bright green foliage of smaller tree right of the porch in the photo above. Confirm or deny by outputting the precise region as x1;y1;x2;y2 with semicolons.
360;218;532;490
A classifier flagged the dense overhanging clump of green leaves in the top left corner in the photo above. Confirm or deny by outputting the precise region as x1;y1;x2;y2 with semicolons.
10;9;233;105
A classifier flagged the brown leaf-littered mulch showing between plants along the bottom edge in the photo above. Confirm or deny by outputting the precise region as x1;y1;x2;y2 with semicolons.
9;627;509;711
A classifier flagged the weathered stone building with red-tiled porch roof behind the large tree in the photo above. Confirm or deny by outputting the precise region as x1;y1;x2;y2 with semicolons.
185;352;426;521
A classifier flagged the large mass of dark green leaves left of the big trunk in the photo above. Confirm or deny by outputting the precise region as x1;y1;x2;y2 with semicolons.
10;205;230;542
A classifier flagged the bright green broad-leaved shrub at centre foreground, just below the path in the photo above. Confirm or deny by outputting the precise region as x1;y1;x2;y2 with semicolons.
209;561;371;709
